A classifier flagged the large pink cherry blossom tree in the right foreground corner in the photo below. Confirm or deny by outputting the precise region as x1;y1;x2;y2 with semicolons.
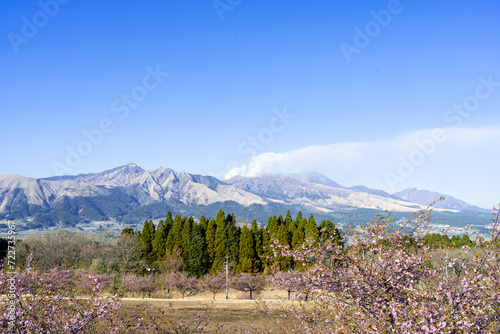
275;202;500;333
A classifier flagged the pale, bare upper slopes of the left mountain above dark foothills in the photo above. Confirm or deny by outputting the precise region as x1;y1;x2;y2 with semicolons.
0;164;266;217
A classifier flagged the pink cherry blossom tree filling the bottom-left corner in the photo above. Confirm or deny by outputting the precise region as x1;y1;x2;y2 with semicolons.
0;269;120;334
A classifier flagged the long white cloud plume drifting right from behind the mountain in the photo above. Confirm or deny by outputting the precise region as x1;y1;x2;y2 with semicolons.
226;127;500;207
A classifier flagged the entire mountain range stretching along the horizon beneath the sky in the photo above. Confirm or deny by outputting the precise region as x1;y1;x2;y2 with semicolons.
0;164;488;229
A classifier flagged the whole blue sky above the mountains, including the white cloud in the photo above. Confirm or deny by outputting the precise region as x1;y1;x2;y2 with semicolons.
0;0;500;208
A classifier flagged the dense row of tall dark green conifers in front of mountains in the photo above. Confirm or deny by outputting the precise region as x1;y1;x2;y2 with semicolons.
139;209;340;276
